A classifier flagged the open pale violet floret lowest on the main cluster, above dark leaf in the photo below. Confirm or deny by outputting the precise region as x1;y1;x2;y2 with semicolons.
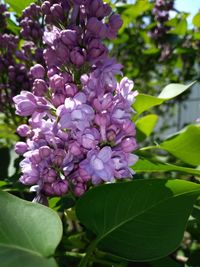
80;146;114;184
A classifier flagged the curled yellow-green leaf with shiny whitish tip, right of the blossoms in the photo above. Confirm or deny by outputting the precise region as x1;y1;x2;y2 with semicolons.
133;82;195;116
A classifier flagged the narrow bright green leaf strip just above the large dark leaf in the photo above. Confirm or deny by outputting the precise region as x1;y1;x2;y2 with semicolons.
133;158;200;176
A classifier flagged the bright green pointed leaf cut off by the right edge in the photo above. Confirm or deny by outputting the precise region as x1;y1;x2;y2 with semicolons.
159;125;200;166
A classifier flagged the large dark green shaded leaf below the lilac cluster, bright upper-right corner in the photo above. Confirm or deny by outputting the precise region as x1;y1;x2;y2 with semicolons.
76;179;200;266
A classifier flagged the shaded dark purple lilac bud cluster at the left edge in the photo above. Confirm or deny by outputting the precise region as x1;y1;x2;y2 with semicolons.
0;33;31;111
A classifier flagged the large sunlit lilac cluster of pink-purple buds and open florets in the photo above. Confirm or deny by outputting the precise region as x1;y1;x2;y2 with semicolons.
13;0;137;200
